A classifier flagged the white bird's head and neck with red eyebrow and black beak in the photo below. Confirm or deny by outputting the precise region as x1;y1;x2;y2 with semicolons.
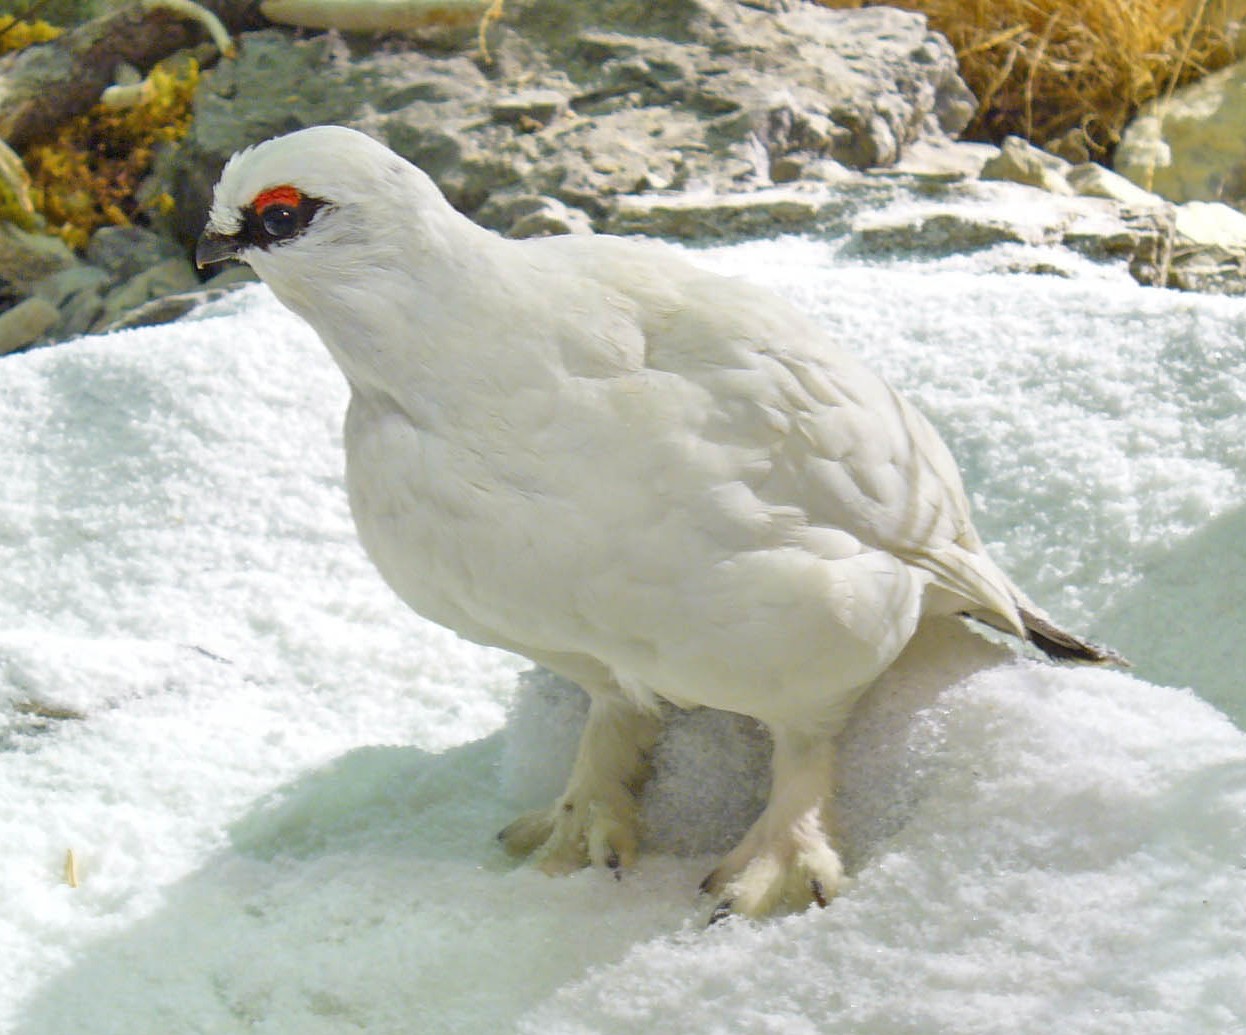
196;126;498;386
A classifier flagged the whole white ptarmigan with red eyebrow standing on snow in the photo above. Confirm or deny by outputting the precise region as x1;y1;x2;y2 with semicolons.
197;127;1119;915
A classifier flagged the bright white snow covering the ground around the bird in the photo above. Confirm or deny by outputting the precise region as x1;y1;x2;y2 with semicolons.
0;240;1246;1035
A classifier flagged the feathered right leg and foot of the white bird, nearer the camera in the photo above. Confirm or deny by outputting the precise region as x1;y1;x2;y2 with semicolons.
701;727;844;923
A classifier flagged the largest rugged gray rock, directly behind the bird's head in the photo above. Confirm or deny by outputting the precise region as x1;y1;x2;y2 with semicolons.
145;0;973;247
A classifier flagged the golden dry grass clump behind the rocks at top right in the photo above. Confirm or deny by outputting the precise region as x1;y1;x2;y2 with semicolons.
821;0;1246;158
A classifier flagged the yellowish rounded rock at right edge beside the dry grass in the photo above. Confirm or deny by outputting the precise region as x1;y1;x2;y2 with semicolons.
1114;61;1246;208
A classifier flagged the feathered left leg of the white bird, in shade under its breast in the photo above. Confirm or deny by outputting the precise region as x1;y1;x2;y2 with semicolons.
497;694;662;874
